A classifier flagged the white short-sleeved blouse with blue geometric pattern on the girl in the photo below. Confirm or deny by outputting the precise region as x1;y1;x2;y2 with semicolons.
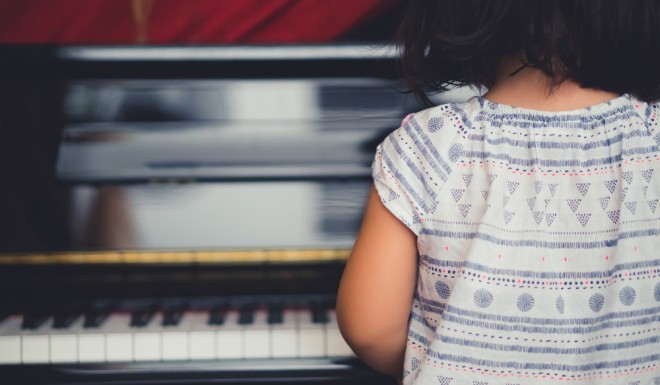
373;95;660;385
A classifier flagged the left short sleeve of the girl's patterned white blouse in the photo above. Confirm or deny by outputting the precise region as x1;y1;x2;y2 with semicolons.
373;108;462;235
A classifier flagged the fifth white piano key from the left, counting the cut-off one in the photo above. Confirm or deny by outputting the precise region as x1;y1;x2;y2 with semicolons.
99;313;133;362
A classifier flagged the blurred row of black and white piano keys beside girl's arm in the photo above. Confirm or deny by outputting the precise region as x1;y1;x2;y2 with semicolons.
0;304;353;365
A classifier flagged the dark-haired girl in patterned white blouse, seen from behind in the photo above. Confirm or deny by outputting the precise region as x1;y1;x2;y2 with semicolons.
337;0;660;385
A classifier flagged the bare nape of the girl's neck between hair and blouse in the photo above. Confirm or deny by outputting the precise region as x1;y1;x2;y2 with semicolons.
484;57;619;112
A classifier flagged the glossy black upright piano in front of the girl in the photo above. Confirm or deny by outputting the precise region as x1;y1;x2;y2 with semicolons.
0;45;419;384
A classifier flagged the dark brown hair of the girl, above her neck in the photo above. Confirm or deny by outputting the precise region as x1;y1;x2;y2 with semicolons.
397;0;660;101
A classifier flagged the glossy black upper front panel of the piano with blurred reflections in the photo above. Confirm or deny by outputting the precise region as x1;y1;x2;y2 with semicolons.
0;47;417;253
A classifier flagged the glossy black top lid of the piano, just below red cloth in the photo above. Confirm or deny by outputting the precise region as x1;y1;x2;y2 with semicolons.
0;44;400;79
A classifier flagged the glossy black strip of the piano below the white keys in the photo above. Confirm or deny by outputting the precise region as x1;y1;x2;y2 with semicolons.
0;358;396;385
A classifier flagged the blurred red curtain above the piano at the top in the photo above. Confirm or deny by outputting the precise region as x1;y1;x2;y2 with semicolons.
0;0;401;44
